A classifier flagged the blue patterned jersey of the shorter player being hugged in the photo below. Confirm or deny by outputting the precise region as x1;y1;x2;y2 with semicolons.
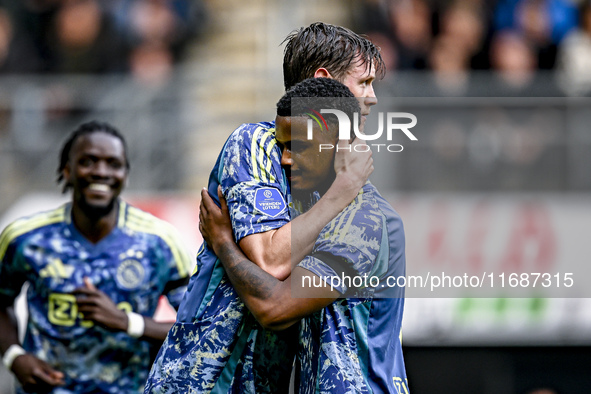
292;182;408;394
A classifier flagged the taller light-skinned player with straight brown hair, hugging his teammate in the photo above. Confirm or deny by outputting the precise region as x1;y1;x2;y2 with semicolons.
146;22;383;393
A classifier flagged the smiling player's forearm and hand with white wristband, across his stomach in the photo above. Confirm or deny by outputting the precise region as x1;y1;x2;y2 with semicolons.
74;279;173;341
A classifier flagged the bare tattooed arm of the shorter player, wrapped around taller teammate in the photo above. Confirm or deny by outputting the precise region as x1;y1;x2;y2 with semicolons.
199;188;341;330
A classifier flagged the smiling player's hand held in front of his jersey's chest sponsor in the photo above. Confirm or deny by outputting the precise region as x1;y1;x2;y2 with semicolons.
73;278;127;331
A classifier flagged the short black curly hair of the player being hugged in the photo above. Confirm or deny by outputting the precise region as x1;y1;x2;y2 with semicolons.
277;78;360;131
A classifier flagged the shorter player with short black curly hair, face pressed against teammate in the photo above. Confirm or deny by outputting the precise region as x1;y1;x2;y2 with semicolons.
199;78;408;393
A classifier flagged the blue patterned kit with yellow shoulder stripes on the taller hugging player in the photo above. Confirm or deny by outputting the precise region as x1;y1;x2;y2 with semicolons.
145;122;297;393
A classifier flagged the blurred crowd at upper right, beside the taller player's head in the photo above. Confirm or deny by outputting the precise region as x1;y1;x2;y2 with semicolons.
356;0;591;96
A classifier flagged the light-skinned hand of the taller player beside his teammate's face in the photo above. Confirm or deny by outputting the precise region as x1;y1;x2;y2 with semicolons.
334;138;374;197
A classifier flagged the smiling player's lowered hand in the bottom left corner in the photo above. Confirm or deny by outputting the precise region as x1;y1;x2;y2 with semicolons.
12;353;66;393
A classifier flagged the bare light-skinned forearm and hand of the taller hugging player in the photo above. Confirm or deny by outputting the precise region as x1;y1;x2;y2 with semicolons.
234;139;373;280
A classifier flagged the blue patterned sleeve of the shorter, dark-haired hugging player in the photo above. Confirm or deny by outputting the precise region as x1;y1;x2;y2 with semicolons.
292;197;386;294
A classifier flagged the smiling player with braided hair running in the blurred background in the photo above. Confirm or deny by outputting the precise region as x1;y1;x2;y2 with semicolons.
0;121;191;393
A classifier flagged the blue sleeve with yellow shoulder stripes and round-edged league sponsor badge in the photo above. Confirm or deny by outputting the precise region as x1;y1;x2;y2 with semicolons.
220;124;289;241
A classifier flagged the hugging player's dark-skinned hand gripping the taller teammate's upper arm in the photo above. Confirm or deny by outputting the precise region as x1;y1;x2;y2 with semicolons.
199;187;234;252
